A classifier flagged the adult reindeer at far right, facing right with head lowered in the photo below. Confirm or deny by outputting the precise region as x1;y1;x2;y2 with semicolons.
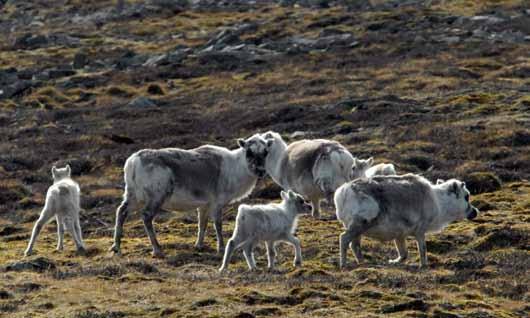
335;174;478;267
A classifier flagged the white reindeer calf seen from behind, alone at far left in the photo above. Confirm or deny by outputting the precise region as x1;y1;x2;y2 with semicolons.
24;165;85;256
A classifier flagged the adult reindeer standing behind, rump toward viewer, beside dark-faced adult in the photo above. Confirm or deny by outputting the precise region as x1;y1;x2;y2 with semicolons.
262;131;353;217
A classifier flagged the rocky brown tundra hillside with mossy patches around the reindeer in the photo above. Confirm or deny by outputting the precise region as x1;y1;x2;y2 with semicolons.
0;0;530;318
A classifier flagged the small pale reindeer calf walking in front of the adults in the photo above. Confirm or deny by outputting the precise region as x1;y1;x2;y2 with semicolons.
219;190;310;272
